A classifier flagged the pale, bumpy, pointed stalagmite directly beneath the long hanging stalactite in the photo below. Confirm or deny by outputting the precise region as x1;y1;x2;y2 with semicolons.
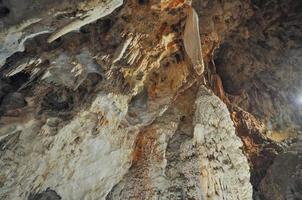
194;88;252;199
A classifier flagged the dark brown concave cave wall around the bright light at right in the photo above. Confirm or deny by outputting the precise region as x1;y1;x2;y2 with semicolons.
216;1;302;138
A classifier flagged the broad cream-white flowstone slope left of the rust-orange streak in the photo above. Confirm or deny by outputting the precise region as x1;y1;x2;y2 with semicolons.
1;94;136;199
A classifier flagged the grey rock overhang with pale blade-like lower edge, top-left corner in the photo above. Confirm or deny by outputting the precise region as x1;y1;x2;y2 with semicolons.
0;0;122;66
